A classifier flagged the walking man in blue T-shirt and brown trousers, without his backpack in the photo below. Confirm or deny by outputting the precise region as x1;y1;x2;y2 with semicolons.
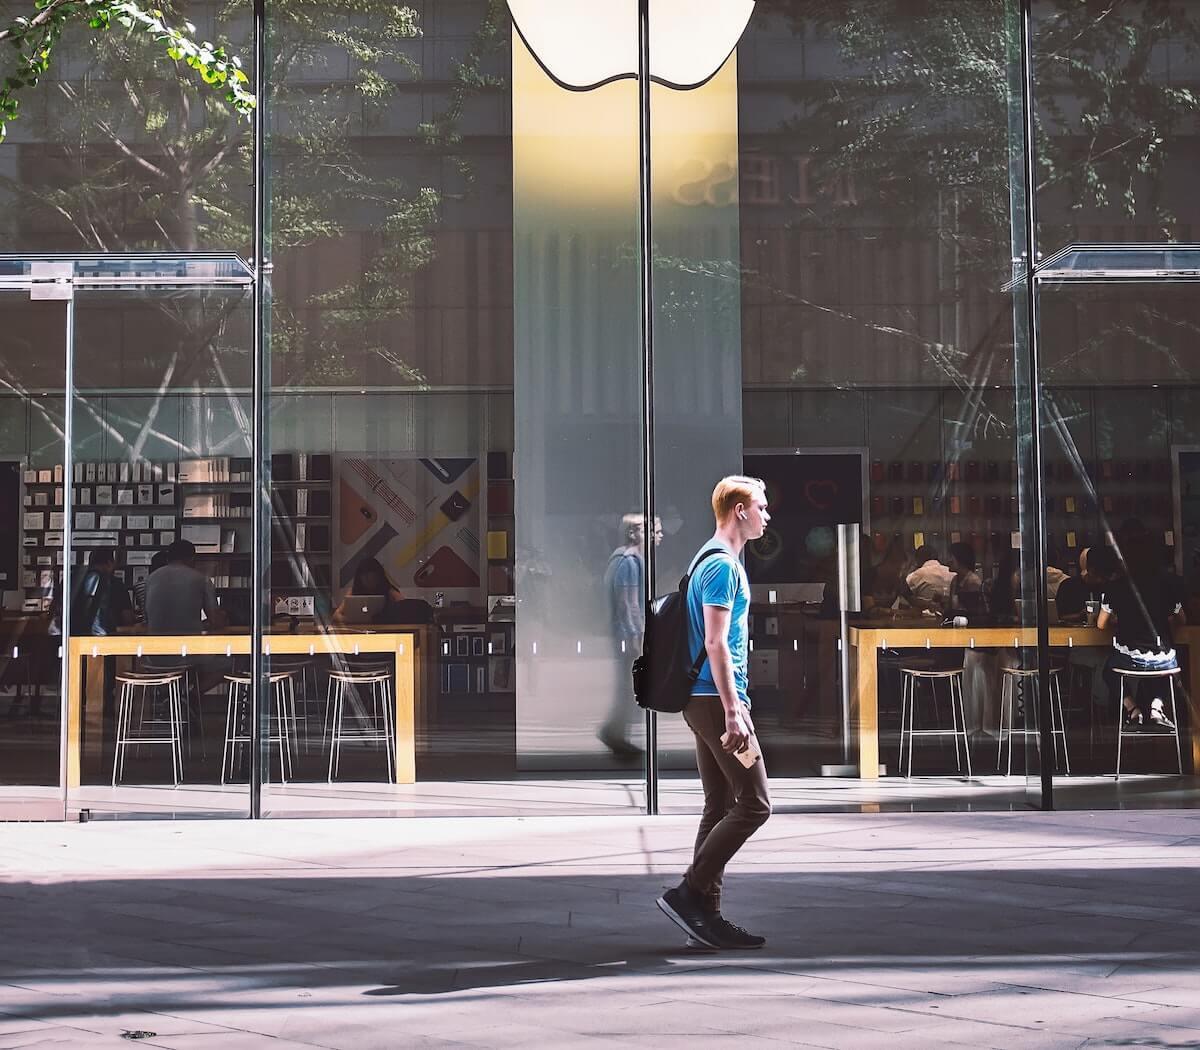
658;475;770;948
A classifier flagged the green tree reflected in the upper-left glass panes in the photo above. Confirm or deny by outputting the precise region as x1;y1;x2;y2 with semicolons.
0;0;505;384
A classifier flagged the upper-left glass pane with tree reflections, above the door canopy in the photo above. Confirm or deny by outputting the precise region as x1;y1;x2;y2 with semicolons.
0;0;253;254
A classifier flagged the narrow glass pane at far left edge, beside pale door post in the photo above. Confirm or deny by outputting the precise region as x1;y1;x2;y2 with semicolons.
0;289;67;820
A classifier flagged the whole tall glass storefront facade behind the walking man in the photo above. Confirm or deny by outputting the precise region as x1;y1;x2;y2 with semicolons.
0;0;1200;817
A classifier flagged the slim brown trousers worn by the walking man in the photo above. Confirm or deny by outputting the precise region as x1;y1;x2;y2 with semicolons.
683;696;770;911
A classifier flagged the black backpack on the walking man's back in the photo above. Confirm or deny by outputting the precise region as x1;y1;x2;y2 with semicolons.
634;547;726;714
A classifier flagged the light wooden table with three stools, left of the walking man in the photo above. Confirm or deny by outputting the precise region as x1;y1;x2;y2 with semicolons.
67;628;431;787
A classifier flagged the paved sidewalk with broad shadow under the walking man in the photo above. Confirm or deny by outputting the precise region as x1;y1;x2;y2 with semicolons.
0;812;1200;1050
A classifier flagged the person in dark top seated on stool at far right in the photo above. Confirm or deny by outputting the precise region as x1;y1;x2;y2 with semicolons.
1097;532;1187;730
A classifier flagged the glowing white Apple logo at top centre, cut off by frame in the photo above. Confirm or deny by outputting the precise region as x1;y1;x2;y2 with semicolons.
509;0;754;91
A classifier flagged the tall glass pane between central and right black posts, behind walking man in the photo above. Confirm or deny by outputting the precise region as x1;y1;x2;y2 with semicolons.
653;0;1037;810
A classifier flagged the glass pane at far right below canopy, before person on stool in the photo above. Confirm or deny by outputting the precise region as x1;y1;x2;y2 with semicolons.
1039;281;1200;809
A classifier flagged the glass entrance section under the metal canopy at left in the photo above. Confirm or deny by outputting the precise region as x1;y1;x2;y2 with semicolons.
0;256;252;817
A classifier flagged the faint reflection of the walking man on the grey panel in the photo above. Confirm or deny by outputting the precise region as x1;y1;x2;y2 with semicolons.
596;514;662;757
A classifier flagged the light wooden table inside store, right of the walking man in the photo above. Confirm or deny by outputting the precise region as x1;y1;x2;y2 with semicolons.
848;619;1200;780
